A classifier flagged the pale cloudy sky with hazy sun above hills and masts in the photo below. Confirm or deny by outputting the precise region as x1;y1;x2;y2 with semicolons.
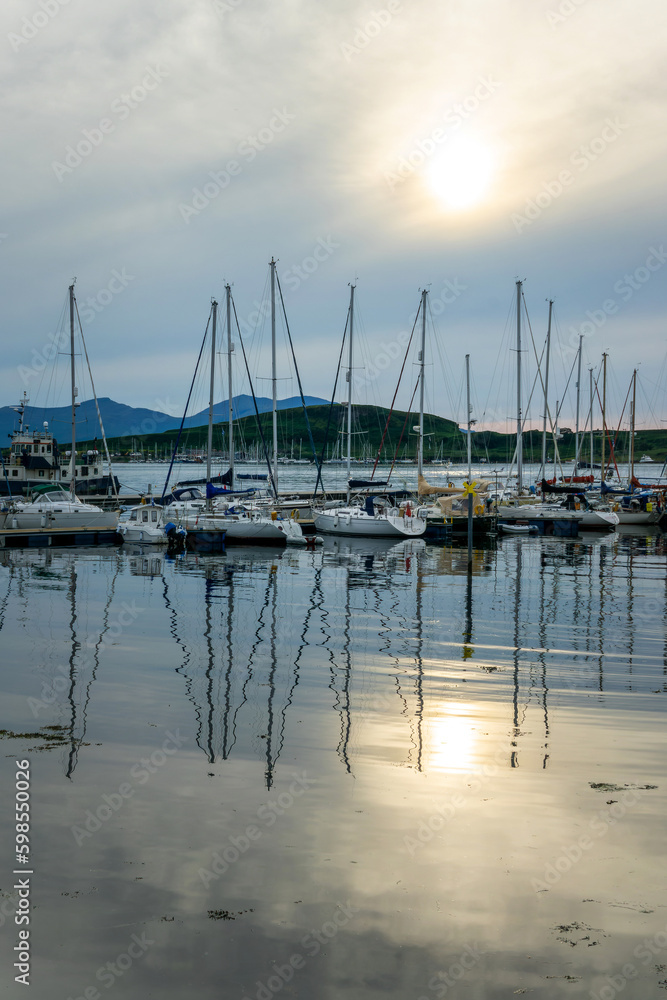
0;0;667;429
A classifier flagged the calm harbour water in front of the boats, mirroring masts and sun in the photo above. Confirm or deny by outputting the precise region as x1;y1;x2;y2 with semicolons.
0;534;667;1000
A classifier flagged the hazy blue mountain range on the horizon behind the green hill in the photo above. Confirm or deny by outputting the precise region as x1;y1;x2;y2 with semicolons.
0;395;329;447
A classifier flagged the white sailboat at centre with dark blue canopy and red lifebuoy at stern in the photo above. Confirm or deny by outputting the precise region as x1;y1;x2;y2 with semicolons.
314;285;426;538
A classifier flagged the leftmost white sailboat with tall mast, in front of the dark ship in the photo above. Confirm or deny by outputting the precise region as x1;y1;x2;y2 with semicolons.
6;284;119;530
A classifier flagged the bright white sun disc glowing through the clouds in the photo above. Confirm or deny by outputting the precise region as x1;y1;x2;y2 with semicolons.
426;137;496;212
